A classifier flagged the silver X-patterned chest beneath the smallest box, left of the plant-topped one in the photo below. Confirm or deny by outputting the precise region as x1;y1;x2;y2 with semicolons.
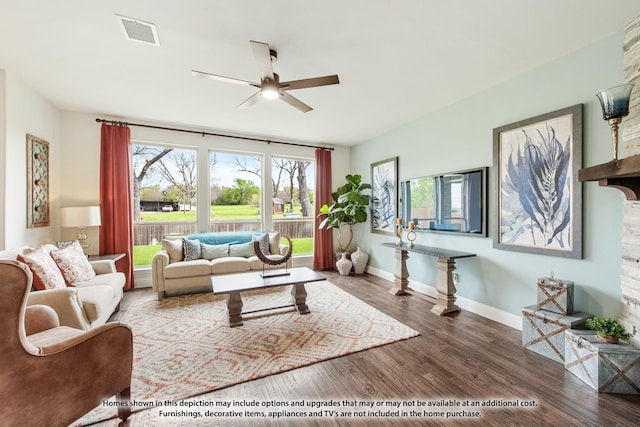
522;305;591;364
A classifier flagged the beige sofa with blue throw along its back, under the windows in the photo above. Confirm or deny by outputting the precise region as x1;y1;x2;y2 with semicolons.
151;232;291;299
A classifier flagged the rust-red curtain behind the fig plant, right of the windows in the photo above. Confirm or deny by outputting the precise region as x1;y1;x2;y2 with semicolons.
313;150;335;270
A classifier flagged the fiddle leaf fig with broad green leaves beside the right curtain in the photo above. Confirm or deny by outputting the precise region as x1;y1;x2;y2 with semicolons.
318;175;371;252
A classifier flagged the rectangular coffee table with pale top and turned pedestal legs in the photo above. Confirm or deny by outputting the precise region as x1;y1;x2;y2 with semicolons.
211;267;326;327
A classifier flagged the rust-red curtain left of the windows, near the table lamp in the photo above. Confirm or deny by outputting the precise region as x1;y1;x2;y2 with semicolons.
100;124;134;289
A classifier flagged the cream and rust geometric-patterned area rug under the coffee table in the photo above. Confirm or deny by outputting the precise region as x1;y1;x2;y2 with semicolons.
78;282;418;425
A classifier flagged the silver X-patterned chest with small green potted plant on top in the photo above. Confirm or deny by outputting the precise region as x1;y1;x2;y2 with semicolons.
564;331;640;394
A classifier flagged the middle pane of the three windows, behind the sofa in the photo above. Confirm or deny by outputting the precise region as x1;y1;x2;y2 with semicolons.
209;151;263;231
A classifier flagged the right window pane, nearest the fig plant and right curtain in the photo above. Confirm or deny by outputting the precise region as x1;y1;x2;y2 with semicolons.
271;157;315;254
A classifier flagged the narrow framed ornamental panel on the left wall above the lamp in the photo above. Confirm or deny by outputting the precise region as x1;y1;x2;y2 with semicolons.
27;134;49;228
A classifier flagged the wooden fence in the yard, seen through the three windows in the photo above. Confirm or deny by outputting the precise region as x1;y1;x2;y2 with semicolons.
133;217;314;246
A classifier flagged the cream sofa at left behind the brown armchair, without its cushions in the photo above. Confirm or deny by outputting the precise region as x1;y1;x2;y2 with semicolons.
0;246;126;331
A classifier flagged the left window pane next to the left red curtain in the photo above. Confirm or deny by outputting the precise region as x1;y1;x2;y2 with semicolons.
131;145;198;266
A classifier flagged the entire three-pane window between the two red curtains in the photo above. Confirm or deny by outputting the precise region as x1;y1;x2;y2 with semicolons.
132;144;315;266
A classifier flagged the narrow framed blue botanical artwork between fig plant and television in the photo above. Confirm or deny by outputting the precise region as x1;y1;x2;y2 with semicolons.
371;157;398;235
